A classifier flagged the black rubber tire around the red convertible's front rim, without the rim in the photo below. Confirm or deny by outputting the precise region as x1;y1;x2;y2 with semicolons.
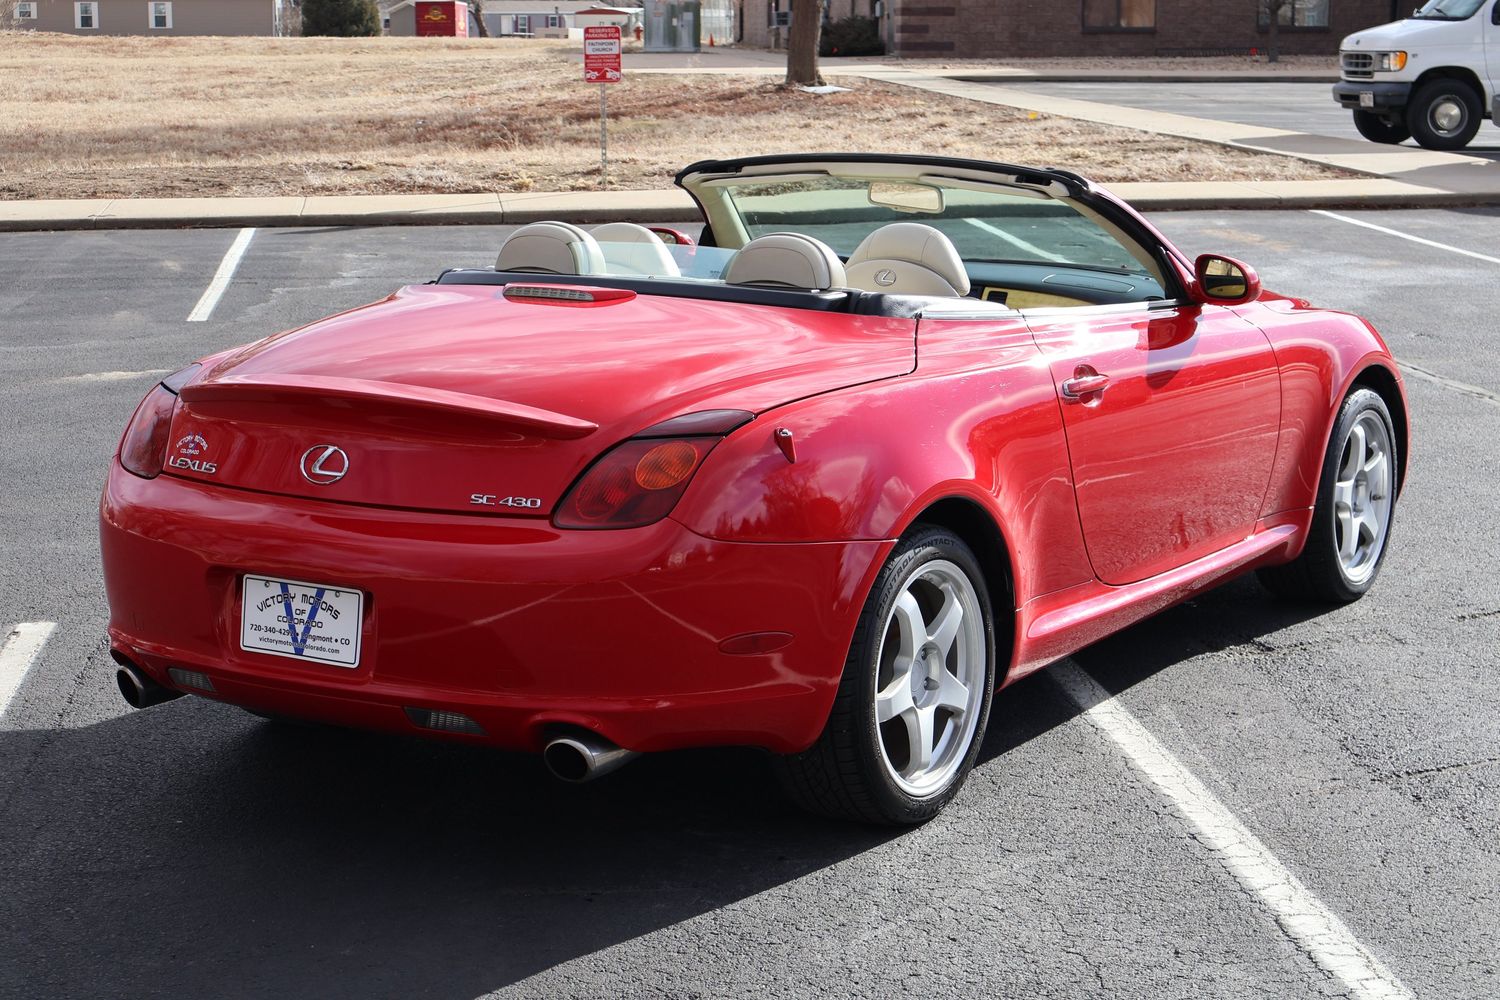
1259;388;1400;604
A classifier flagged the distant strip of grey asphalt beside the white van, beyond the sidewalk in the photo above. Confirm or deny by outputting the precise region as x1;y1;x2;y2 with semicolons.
1007;82;1500;159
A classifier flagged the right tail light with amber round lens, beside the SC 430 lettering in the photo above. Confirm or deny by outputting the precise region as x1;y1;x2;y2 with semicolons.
552;409;755;529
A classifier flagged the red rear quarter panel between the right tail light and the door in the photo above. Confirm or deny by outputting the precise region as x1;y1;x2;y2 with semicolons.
674;316;1092;604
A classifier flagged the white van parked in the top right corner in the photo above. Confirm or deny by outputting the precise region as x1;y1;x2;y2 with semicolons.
1334;0;1500;150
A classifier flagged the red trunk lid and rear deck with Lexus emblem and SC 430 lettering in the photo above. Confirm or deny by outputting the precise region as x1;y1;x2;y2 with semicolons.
167;285;915;516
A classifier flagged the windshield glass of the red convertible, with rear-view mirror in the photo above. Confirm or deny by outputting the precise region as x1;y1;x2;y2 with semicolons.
714;177;1155;276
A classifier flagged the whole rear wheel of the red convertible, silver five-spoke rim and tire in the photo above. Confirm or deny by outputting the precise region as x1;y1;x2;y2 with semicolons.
779;528;995;825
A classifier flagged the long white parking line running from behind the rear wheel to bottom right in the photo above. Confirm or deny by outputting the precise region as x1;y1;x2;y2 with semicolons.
1052;663;1413;1000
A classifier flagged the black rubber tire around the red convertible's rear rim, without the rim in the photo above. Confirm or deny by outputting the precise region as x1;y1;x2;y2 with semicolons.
777;525;996;826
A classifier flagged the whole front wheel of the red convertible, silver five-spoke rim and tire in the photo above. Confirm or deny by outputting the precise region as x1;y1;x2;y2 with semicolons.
1260;388;1398;603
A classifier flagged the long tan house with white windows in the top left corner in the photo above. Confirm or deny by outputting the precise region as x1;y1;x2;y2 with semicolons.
0;0;282;34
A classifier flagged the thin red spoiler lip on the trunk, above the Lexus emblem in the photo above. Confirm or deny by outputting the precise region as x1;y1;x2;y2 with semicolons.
180;375;599;441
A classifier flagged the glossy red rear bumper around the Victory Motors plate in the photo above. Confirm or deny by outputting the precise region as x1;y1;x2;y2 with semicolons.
101;463;893;753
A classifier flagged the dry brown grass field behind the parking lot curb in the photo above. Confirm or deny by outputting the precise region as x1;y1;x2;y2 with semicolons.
0;33;1337;198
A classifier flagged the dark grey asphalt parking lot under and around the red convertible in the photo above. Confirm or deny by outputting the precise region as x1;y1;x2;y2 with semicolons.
0;206;1500;1000
